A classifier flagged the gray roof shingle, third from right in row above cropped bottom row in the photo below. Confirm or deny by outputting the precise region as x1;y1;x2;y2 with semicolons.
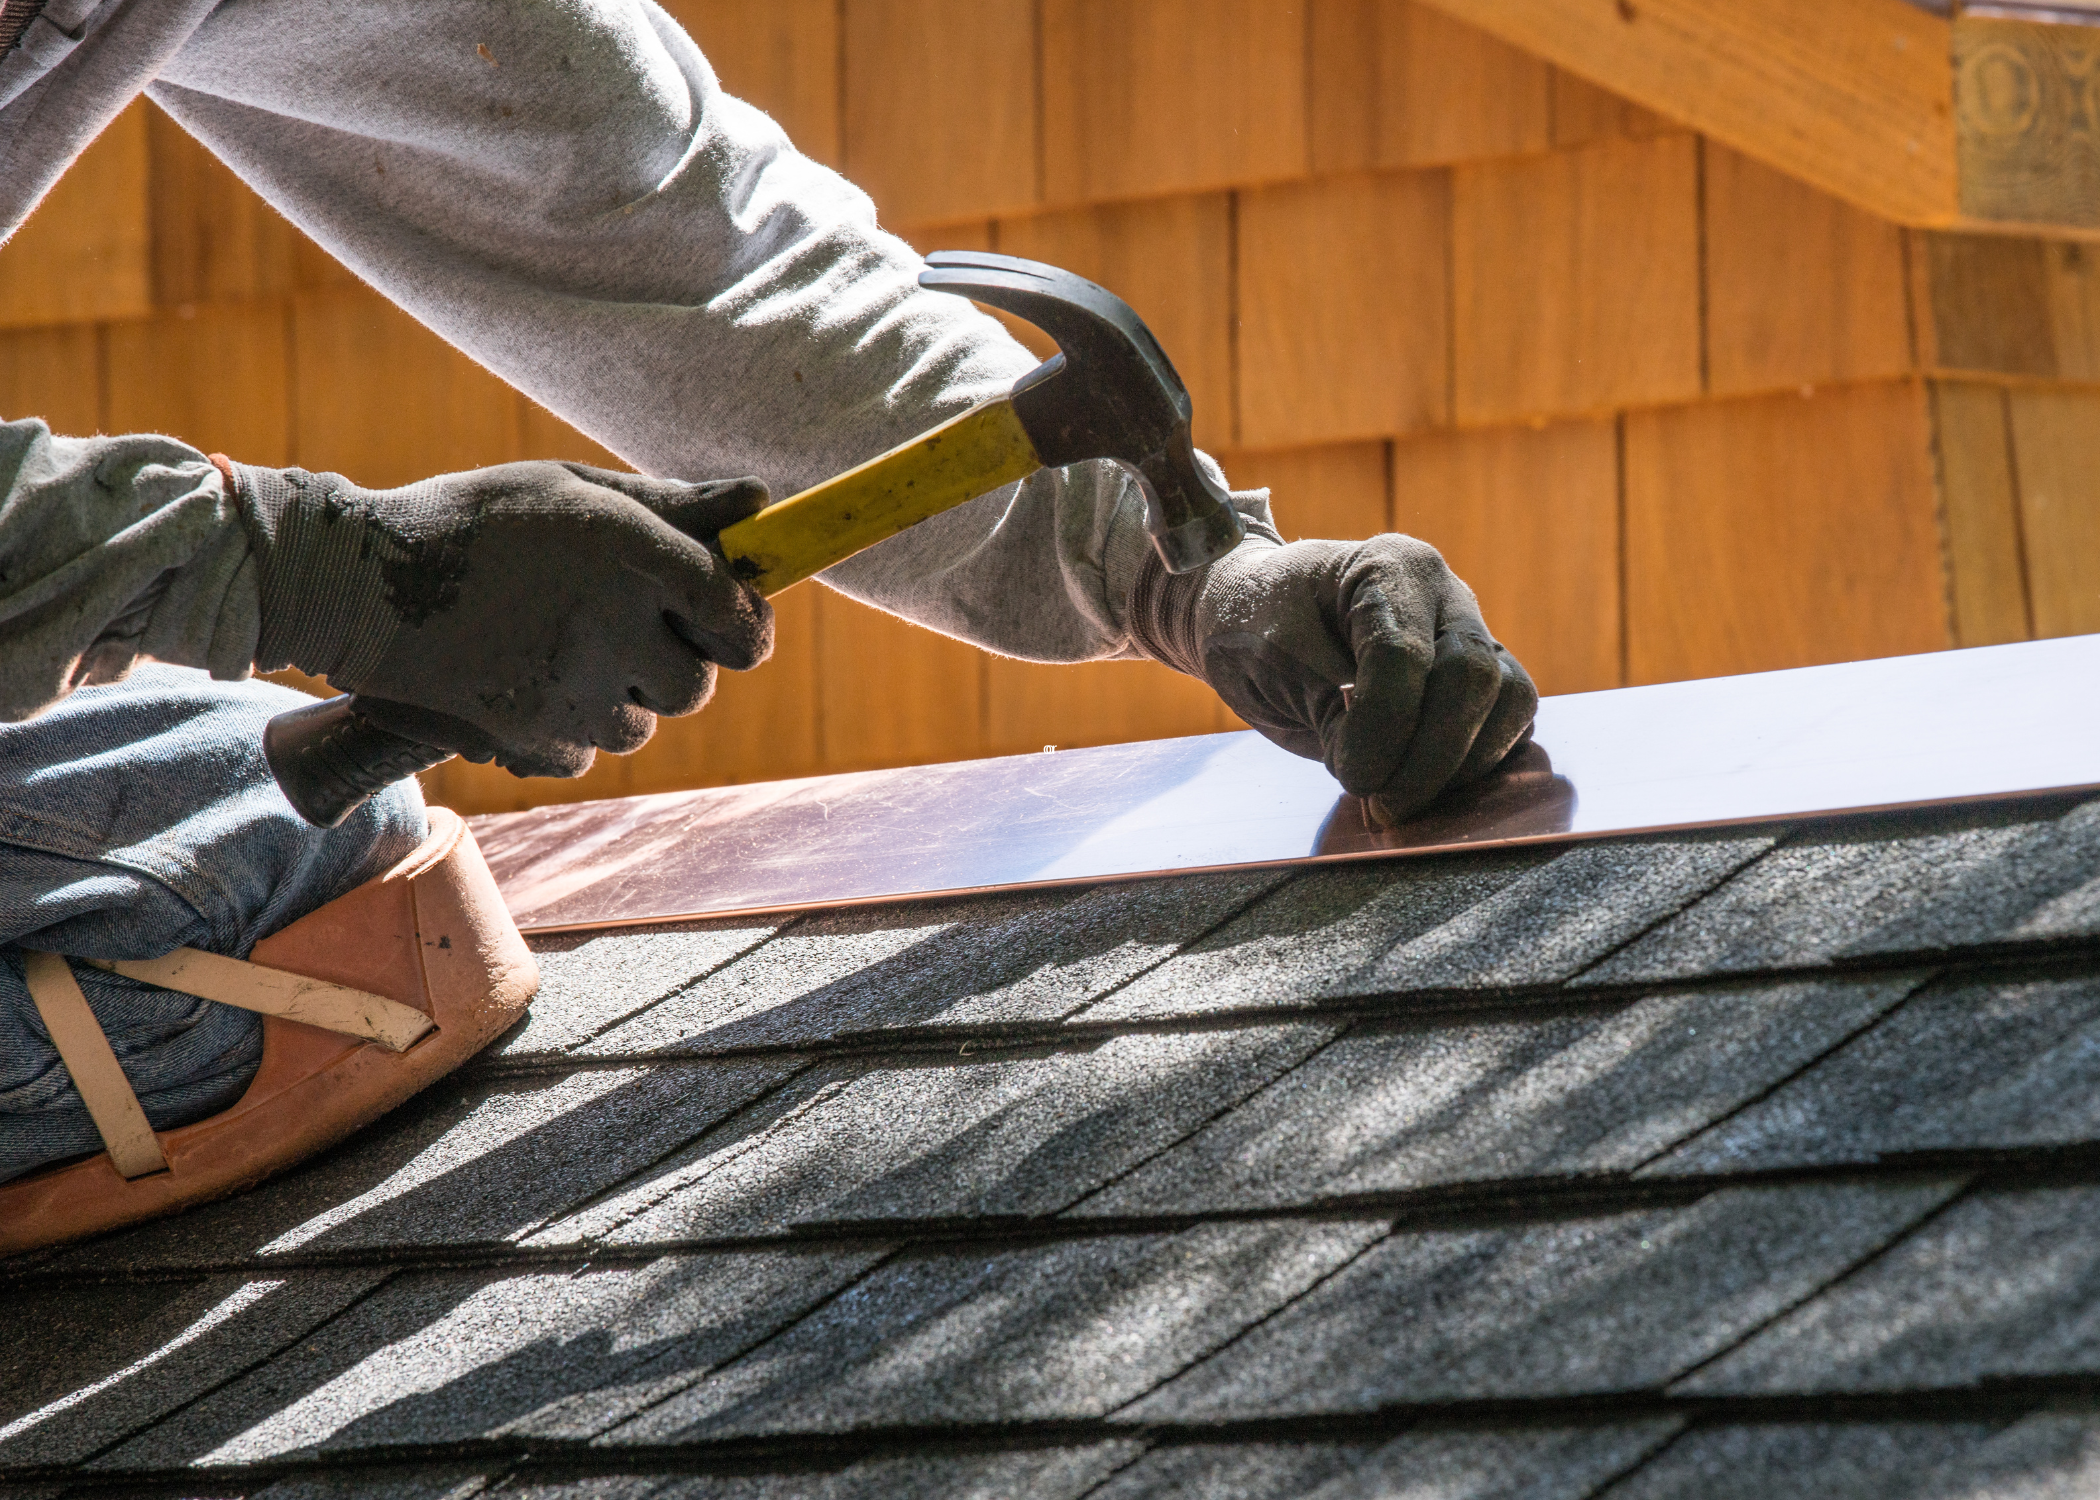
601;1221;1386;1443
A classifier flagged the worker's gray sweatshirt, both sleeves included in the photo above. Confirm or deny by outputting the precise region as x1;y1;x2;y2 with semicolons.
0;0;1275;718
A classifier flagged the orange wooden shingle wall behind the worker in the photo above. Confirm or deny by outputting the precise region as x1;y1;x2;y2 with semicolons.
0;0;2100;809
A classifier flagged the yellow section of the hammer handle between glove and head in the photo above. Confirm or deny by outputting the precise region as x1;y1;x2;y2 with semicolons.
720;397;1042;595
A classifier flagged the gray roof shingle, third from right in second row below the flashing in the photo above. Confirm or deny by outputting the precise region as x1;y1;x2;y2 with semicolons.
533;1025;1334;1244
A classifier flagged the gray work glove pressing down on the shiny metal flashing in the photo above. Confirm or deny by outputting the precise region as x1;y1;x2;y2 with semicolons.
1130;534;1539;824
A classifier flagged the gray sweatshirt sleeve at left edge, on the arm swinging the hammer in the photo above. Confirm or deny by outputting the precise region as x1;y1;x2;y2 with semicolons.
0;420;258;723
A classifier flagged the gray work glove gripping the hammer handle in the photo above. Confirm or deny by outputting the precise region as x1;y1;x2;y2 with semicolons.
214;456;773;775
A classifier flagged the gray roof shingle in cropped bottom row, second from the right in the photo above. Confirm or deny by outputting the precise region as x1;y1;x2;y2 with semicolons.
1092;1418;1680;1500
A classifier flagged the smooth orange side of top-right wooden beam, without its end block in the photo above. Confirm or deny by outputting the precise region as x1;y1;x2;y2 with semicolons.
1424;0;1961;225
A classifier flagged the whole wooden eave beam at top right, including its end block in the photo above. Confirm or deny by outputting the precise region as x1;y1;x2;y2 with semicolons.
1420;0;2100;237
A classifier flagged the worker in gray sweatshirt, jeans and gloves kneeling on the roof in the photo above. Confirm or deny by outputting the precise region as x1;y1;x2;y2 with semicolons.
0;0;1535;1181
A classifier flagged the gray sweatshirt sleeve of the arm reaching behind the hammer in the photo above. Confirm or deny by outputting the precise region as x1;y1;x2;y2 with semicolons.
139;0;1266;662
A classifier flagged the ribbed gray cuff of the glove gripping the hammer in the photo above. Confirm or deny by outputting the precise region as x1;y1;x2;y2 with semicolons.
212;454;435;691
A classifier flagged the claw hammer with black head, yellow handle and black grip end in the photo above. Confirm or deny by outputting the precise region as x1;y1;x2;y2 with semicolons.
263;250;1243;828
